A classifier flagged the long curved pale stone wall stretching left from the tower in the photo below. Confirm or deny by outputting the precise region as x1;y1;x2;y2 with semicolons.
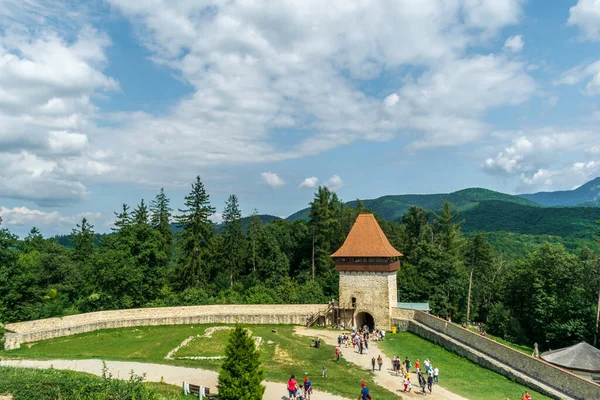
4;304;327;350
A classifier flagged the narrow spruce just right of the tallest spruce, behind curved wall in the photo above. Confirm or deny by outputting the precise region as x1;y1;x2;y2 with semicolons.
222;194;246;287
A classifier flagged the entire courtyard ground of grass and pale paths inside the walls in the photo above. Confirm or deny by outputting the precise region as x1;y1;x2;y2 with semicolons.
2;324;546;400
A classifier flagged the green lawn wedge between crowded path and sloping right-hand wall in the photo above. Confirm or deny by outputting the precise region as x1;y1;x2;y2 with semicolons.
379;332;549;400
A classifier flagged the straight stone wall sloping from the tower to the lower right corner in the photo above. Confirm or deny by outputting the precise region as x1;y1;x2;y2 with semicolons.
408;311;600;400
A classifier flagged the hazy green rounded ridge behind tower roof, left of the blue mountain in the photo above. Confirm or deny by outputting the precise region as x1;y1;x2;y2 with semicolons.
286;188;539;221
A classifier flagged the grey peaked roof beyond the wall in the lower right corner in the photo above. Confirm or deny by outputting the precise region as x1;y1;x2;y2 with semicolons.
541;342;600;382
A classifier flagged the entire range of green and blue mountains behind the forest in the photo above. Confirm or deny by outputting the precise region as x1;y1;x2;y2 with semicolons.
252;178;600;250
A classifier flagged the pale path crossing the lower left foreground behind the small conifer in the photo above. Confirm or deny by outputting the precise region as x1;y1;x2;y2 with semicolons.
1;360;348;400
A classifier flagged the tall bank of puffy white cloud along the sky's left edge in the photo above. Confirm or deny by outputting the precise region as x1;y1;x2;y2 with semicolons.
0;17;118;205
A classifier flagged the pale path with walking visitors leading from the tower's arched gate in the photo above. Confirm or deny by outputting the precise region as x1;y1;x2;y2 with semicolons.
295;326;466;400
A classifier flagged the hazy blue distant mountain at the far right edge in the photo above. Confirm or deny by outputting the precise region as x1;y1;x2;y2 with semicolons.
520;177;600;207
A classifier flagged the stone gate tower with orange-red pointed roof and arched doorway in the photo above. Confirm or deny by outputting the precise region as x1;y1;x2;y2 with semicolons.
331;214;402;329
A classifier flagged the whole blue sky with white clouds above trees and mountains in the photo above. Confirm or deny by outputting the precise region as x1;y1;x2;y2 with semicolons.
0;0;600;236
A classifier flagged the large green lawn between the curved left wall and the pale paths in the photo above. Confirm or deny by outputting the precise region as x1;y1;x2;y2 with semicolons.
2;324;398;400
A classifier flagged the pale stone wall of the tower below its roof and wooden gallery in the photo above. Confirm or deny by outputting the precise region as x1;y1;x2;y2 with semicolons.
339;271;397;329
